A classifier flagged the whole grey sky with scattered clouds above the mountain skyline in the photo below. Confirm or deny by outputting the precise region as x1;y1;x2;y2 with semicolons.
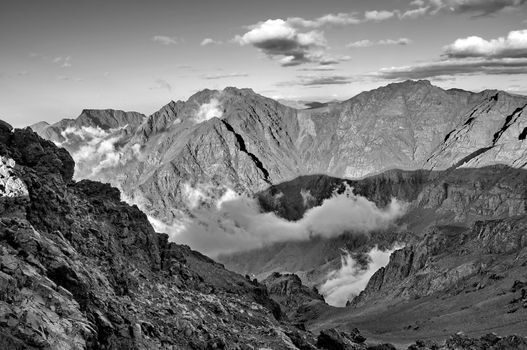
0;0;527;127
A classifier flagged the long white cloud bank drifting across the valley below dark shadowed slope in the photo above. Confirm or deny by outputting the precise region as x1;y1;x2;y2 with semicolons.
153;186;405;257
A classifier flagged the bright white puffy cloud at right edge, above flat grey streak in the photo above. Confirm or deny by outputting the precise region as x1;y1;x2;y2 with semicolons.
444;29;527;58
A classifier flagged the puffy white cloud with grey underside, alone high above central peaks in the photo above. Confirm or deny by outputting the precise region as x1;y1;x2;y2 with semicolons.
234;17;349;67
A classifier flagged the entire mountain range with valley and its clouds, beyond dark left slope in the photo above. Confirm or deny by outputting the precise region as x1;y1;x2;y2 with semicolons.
22;81;527;349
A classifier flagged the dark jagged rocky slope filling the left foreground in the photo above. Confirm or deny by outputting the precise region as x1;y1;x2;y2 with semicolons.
0;124;330;349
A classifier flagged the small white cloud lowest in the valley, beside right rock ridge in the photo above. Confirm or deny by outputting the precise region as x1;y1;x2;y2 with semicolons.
319;246;402;307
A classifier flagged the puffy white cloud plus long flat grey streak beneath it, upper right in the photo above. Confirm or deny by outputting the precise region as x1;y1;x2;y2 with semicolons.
374;30;527;79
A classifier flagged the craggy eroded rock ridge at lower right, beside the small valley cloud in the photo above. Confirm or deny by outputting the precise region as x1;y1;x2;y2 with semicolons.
351;215;527;312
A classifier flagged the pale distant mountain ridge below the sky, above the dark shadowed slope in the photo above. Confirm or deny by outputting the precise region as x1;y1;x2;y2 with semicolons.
29;81;527;221
